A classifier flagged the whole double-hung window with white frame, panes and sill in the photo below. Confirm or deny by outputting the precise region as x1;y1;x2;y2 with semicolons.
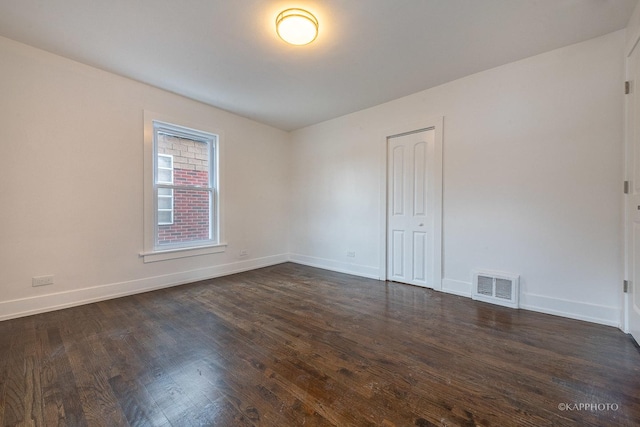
142;112;224;262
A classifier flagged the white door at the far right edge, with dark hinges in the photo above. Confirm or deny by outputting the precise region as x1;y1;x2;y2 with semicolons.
625;39;640;343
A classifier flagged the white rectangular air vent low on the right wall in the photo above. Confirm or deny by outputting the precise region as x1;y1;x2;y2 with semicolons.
472;271;520;308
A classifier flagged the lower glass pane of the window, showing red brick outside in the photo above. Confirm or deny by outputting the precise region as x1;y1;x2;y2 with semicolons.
158;189;211;245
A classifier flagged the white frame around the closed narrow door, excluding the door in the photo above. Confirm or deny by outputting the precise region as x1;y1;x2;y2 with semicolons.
379;116;444;290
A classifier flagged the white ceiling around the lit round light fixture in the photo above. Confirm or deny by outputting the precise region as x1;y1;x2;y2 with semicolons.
0;0;638;130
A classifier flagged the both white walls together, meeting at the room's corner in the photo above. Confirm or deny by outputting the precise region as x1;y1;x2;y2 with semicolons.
0;31;626;325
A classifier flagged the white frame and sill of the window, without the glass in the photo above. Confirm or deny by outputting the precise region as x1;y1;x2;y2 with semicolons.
140;111;227;263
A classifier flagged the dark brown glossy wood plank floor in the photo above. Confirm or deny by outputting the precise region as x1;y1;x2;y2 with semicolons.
0;264;640;427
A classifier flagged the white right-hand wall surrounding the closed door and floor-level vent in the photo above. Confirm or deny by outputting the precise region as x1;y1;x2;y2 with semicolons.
290;30;625;326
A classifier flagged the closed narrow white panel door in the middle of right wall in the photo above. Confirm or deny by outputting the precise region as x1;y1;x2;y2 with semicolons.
387;129;435;287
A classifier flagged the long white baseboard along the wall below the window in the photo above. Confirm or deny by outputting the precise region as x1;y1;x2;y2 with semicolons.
0;254;289;321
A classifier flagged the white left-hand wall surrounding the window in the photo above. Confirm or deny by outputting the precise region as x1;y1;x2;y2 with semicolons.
0;38;290;320
